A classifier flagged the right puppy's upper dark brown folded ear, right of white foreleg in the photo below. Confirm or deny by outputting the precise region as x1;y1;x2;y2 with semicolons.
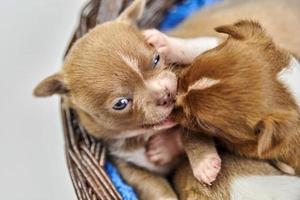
215;20;264;40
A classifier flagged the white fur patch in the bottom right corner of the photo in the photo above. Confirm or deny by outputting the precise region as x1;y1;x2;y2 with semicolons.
230;176;300;200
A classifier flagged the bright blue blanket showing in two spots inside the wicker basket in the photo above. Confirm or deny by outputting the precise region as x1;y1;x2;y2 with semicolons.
105;0;221;200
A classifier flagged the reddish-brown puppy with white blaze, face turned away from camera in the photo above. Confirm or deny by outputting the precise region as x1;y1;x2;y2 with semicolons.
174;20;300;174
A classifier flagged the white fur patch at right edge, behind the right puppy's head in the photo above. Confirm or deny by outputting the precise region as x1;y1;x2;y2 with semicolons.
277;57;300;106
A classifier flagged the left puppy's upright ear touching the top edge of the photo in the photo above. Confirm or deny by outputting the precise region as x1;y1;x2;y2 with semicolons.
117;0;146;24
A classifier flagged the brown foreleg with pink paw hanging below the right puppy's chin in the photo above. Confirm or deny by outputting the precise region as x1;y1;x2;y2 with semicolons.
182;132;221;185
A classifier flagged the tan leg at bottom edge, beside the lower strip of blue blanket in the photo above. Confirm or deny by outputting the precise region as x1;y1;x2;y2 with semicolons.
113;159;178;200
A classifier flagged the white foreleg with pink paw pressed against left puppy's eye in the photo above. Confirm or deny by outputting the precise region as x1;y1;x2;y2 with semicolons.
144;29;220;64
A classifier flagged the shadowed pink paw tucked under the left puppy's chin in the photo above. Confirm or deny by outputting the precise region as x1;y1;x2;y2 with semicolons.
146;129;183;165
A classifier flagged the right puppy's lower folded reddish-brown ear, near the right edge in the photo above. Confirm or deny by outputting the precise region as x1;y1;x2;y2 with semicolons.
254;111;298;157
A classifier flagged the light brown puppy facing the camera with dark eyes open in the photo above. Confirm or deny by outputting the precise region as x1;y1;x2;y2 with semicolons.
34;0;223;200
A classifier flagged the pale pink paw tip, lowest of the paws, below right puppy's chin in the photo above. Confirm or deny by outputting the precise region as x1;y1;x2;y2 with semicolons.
192;154;221;185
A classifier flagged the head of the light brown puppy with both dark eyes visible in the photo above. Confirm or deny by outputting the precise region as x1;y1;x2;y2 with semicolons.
34;0;177;137
